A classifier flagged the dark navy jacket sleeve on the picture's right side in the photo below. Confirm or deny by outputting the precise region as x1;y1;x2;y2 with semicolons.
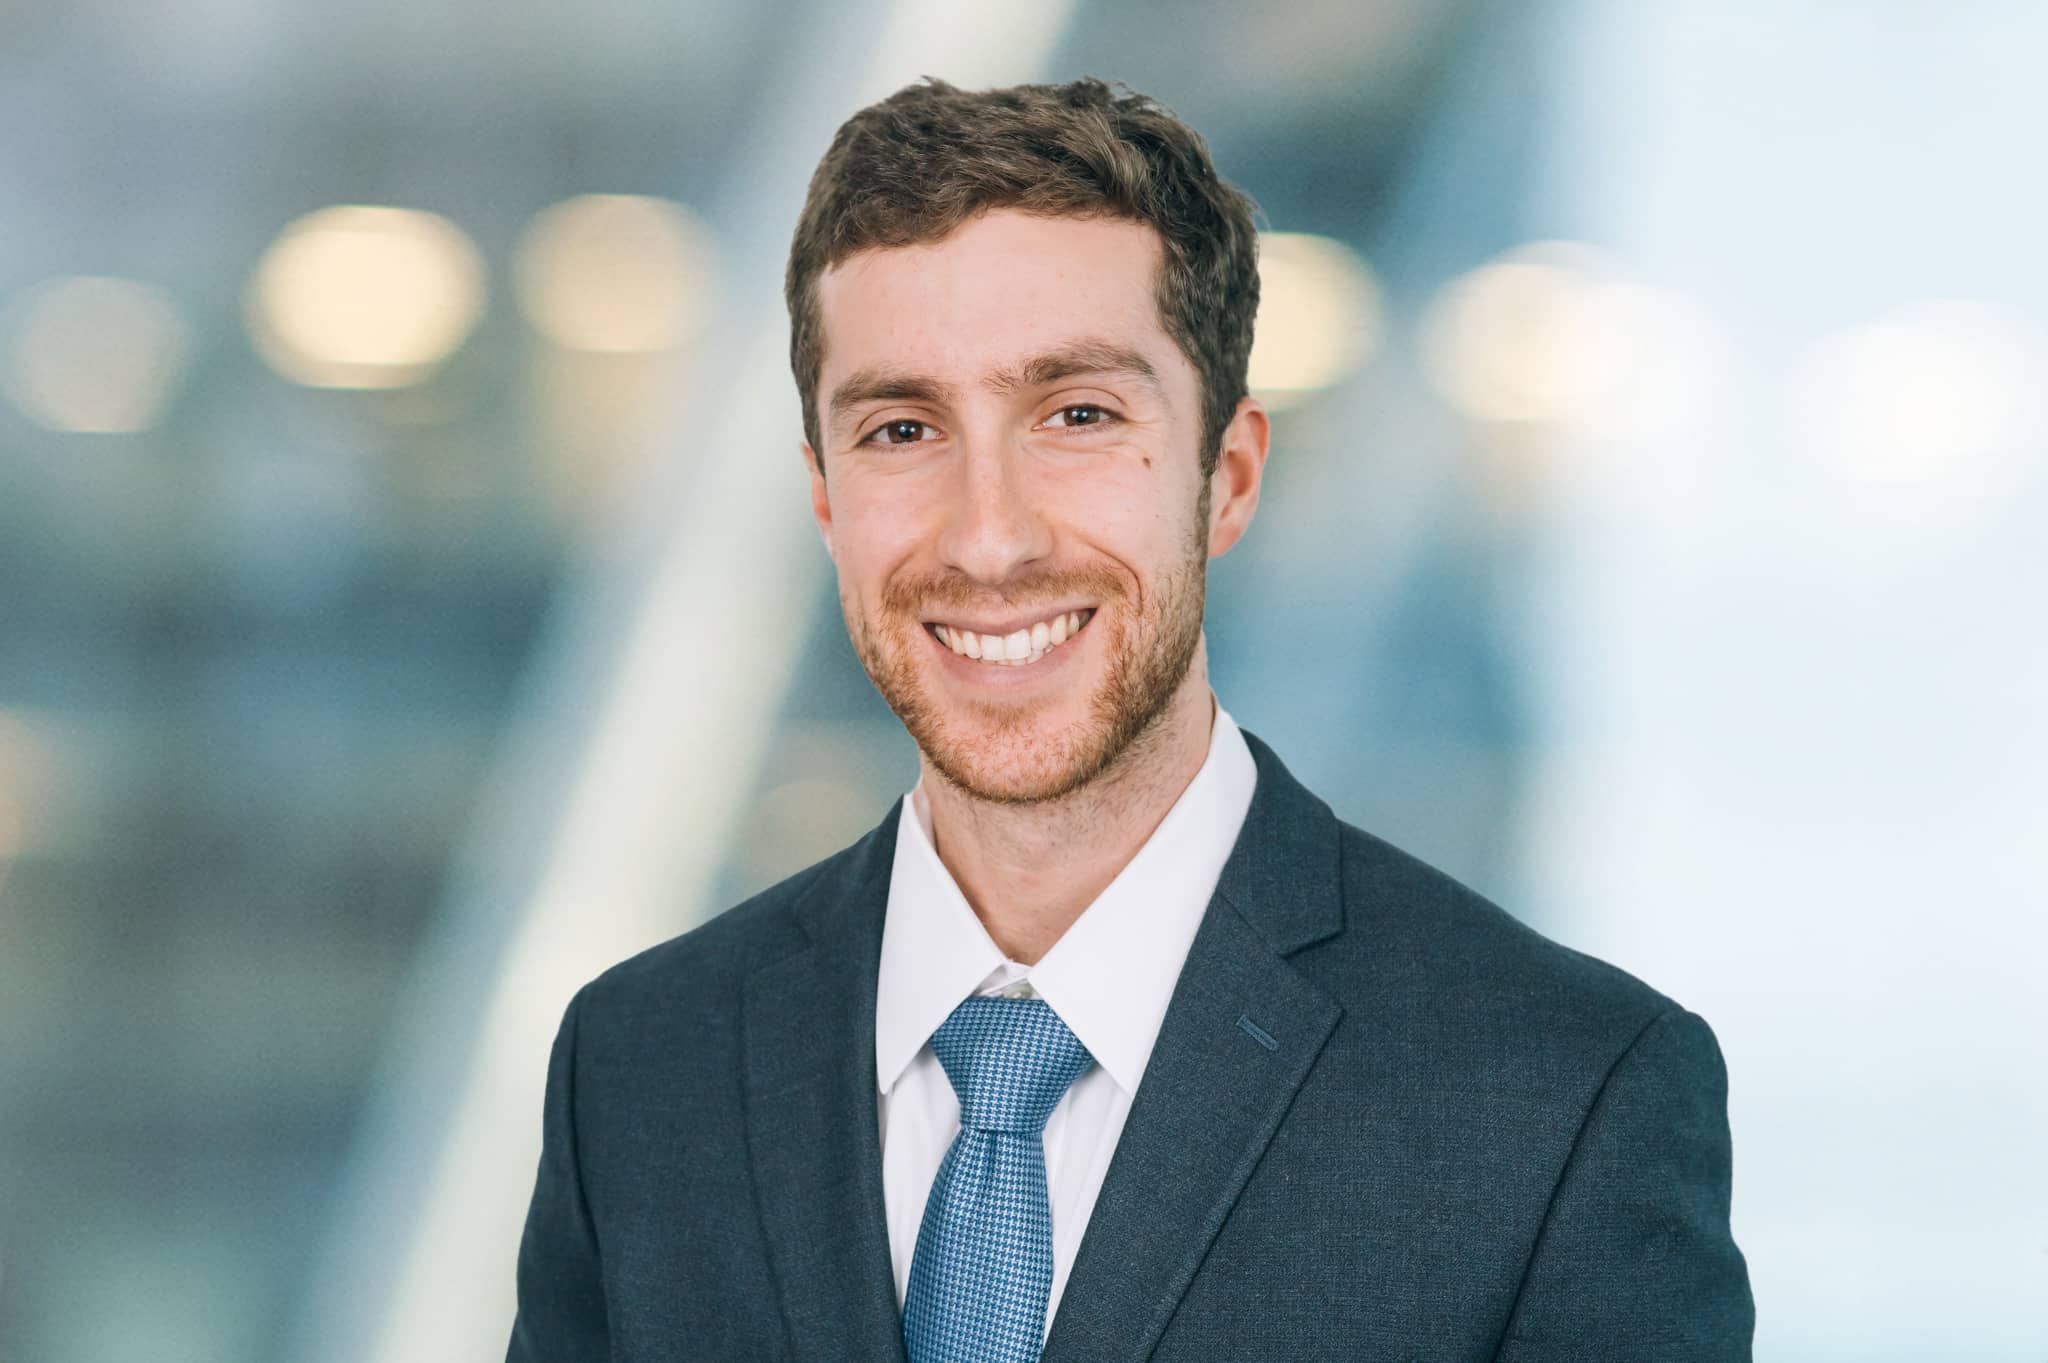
1497;1009;1755;1363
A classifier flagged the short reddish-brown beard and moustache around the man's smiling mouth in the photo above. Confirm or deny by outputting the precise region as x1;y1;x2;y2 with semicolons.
840;509;1208;804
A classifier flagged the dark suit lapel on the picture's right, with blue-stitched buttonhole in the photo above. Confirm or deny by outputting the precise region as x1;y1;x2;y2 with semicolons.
1044;733;1343;1363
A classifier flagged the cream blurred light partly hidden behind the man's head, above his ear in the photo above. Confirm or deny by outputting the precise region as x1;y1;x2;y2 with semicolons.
1249;231;1380;409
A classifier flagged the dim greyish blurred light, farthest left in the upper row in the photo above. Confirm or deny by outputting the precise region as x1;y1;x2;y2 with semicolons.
4;274;190;434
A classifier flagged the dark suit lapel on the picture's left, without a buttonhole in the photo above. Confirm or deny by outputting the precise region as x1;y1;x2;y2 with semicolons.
741;806;903;1361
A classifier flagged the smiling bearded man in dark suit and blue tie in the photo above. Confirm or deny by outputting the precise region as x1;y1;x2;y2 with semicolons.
510;82;1753;1363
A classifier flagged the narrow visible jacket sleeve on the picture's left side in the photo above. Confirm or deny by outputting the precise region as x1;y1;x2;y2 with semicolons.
506;995;610;1363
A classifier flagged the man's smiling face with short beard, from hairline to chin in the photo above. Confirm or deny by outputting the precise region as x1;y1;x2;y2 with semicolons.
813;211;1235;802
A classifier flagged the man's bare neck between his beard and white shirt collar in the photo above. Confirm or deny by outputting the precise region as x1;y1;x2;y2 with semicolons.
922;641;1214;966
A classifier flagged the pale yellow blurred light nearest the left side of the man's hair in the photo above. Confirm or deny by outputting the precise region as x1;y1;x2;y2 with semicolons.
512;194;713;352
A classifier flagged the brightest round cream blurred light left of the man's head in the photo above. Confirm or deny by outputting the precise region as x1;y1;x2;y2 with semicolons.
246;205;483;389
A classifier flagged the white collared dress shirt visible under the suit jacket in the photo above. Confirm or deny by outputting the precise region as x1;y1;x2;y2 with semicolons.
874;706;1257;1334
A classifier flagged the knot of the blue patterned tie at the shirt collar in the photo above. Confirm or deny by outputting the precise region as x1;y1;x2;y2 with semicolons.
932;997;1094;1136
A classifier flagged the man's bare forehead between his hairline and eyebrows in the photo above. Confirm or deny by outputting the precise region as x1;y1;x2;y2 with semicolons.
817;209;1192;391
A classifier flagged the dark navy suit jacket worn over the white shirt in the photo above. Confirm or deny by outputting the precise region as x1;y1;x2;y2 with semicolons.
508;735;1753;1363
